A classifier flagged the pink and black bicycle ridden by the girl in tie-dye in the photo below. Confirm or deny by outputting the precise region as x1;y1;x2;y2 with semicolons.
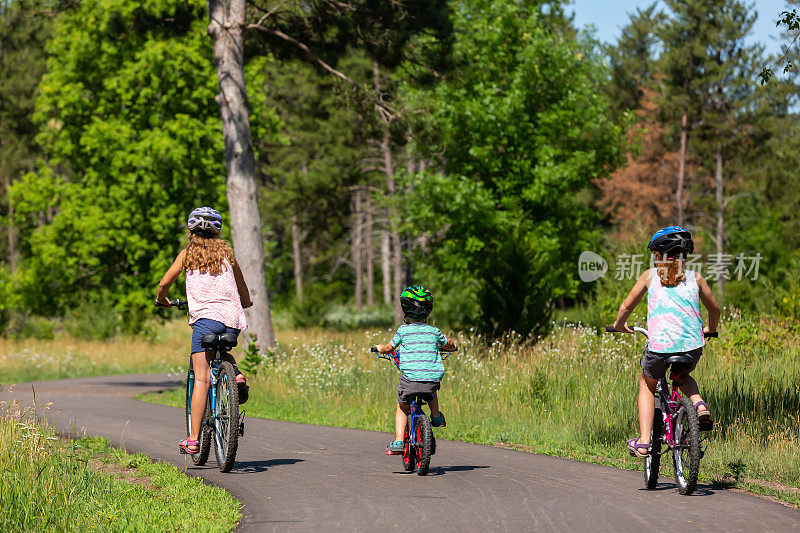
606;326;718;494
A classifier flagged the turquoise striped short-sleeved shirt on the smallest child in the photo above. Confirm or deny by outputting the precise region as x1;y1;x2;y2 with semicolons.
391;322;447;381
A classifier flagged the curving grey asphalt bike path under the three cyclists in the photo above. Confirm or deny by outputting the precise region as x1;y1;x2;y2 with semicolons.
0;374;800;533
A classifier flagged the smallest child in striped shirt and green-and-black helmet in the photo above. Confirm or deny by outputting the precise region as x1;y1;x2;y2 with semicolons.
375;285;457;454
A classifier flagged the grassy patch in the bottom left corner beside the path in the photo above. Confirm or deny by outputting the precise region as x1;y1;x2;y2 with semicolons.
0;406;241;531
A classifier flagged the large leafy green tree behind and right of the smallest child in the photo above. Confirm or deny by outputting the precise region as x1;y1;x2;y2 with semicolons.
400;0;622;335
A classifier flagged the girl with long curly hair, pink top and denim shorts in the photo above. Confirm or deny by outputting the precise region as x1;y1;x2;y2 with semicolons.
156;207;253;454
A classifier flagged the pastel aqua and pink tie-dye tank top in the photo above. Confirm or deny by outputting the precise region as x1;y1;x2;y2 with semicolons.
647;269;705;353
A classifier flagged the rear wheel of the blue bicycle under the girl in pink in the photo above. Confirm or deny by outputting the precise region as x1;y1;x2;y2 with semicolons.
214;361;239;472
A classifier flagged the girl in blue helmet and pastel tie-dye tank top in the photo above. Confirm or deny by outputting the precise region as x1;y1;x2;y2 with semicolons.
614;226;720;457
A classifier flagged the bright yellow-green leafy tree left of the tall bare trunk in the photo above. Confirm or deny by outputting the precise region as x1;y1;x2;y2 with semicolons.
6;1;236;321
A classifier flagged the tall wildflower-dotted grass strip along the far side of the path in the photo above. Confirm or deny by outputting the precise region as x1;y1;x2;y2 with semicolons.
144;316;800;505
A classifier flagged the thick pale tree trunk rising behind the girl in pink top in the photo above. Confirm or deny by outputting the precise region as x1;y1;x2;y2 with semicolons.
208;0;275;348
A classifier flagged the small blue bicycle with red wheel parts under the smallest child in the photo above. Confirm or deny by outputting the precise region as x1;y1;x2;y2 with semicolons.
370;346;450;476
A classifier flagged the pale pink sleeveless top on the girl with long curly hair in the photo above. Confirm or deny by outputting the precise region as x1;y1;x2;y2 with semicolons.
186;259;247;330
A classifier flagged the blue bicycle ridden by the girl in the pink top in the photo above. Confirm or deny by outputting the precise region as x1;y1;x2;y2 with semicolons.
156;300;244;472
